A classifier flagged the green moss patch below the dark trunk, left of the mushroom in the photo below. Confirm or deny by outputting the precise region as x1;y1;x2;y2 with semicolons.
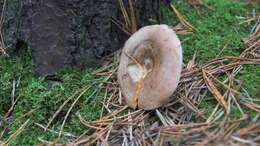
0;52;102;145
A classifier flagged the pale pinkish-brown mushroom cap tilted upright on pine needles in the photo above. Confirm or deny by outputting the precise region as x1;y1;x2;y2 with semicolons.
118;25;182;110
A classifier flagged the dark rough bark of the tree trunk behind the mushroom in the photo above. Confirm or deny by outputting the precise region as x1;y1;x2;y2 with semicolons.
1;0;160;75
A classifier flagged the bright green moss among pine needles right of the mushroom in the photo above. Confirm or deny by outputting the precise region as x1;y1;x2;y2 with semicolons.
163;0;260;116
